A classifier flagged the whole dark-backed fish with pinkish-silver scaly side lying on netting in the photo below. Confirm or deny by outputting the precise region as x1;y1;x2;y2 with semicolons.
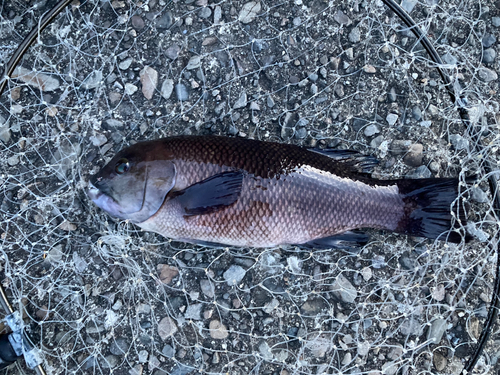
86;135;470;248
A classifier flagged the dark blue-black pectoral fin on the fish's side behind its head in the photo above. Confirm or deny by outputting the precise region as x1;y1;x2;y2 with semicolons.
172;171;243;216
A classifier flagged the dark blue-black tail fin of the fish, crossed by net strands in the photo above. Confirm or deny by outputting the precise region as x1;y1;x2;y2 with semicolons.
396;178;472;243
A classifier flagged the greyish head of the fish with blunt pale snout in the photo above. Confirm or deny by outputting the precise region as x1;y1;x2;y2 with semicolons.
86;142;176;223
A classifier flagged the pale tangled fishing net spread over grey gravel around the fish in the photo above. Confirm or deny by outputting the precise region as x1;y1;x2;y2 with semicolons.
0;0;500;375
